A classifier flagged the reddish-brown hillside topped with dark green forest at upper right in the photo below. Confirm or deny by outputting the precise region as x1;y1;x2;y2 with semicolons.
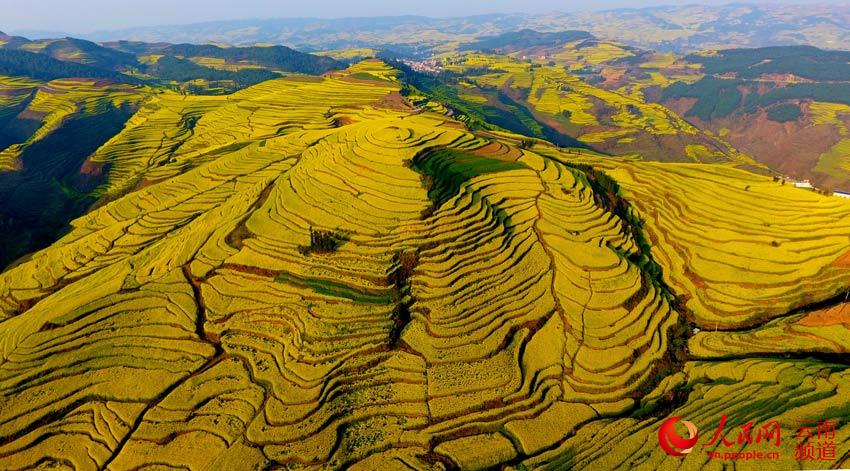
648;47;850;191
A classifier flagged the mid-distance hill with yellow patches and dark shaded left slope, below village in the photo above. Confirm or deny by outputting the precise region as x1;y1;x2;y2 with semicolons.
394;49;755;165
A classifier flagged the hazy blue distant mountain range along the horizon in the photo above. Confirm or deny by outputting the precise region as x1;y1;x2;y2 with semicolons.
11;4;850;52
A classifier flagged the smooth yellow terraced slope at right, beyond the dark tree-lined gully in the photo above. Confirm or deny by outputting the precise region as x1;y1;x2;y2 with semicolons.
536;154;850;329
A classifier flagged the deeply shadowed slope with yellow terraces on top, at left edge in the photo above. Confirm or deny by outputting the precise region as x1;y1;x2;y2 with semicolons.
0;77;150;268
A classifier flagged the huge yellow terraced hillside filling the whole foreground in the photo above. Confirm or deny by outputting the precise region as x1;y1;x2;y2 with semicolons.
0;57;850;470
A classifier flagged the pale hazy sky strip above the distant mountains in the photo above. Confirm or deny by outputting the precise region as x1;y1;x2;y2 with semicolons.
0;0;836;33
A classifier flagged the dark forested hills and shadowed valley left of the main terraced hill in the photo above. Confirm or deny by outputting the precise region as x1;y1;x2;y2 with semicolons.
0;35;344;267
